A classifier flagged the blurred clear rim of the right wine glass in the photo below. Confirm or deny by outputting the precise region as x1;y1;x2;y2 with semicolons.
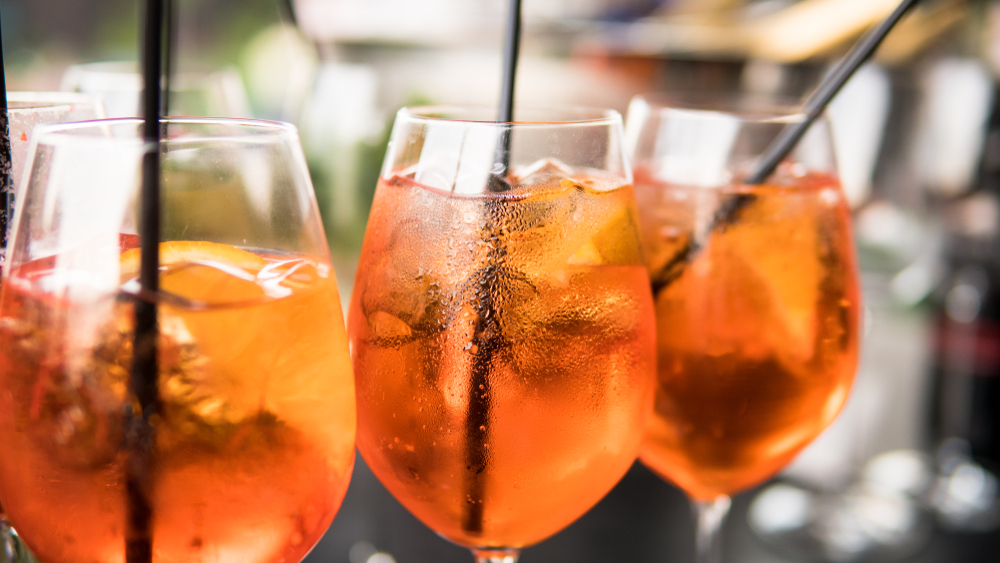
631;91;812;124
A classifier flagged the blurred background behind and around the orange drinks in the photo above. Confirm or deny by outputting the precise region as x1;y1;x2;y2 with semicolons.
0;0;1000;563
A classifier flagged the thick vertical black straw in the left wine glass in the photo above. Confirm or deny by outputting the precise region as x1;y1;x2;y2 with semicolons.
125;0;164;563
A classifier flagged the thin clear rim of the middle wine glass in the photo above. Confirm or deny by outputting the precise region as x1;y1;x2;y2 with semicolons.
397;104;622;128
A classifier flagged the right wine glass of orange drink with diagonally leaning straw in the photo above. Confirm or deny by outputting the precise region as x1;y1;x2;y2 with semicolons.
627;97;860;563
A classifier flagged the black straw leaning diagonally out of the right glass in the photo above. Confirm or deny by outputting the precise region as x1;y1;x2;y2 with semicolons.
652;0;920;295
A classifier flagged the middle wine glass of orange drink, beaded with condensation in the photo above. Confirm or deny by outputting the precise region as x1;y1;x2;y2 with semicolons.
348;107;655;563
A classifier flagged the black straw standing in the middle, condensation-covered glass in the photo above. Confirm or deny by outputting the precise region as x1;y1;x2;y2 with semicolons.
462;0;521;535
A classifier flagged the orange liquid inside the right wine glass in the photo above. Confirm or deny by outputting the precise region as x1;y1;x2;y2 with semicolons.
637;170;859;500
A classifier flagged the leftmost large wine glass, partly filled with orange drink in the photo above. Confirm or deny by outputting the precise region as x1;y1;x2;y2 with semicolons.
0;119;356;563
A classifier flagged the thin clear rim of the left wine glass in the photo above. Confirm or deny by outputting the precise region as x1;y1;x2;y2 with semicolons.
32;117;298;146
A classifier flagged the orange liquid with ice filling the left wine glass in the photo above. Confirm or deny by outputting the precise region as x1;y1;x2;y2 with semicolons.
0;249;356;563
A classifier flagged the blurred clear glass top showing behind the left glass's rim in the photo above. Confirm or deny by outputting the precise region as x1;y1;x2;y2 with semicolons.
60;61;251;118
